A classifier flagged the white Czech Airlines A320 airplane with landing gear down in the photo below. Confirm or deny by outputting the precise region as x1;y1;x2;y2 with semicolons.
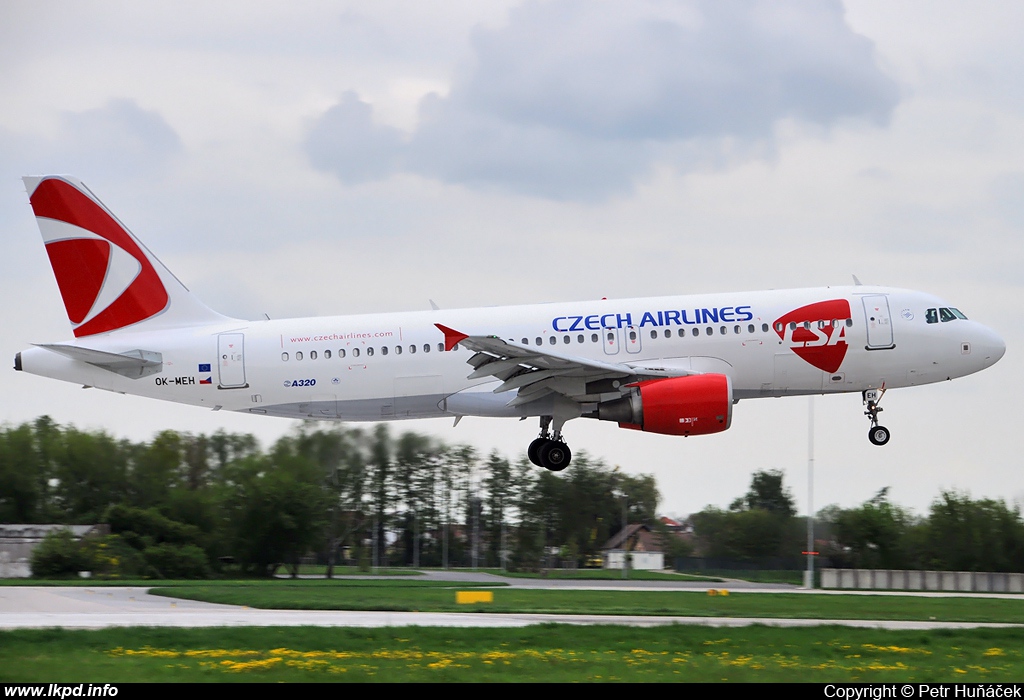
14;175;1006;471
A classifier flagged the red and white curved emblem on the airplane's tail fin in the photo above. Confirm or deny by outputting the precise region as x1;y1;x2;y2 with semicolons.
31;178;170;338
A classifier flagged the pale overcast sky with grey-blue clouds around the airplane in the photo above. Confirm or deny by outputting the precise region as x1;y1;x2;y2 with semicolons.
0;0;1024;516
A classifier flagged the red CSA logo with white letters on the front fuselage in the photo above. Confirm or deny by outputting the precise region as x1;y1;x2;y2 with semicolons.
772;299;850;371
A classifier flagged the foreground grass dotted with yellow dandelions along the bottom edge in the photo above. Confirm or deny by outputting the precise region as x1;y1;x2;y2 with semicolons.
0;625;1024;683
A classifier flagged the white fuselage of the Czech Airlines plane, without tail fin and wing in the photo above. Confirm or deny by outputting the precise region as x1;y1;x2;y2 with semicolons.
20;286;1005;421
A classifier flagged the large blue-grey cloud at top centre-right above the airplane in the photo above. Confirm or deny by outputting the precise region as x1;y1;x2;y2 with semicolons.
306;0;899;200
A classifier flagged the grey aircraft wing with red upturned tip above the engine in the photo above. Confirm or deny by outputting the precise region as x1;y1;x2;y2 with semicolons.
434;323;699;406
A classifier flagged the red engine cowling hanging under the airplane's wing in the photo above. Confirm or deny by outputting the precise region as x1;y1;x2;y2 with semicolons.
598;375;732;435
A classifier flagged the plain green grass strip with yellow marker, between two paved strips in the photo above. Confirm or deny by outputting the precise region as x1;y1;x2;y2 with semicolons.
152;579;1024;623
